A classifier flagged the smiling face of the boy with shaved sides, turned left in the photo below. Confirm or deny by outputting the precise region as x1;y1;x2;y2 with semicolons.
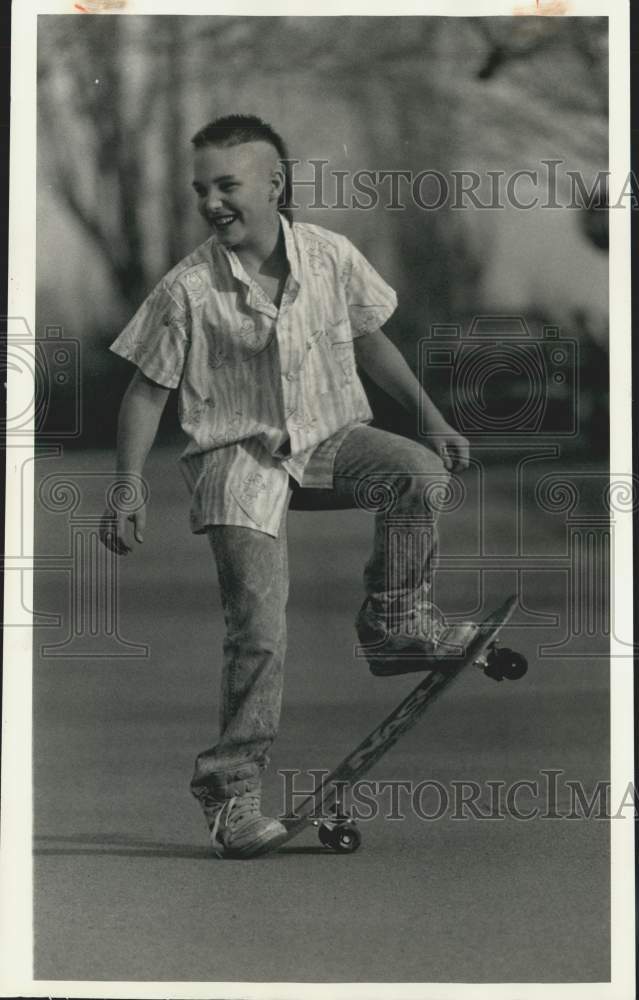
193;142;284;249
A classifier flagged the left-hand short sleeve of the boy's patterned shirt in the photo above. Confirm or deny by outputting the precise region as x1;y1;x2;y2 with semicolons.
110;281;189;389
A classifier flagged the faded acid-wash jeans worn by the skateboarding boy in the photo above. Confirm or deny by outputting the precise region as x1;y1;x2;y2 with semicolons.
191;425;448;798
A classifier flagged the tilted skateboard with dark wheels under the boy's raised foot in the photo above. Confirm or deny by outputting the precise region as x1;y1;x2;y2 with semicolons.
268;595;528;853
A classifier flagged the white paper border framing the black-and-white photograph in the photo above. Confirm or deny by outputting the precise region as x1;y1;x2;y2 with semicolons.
0;0;635;1000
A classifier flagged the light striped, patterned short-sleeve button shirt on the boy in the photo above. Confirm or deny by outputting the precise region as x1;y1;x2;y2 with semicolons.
111;217;397;536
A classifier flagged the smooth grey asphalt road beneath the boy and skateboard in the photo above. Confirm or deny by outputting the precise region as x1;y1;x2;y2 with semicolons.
34;451;609;983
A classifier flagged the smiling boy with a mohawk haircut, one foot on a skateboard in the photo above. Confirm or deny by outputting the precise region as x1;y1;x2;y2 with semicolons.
102;115;470;857
